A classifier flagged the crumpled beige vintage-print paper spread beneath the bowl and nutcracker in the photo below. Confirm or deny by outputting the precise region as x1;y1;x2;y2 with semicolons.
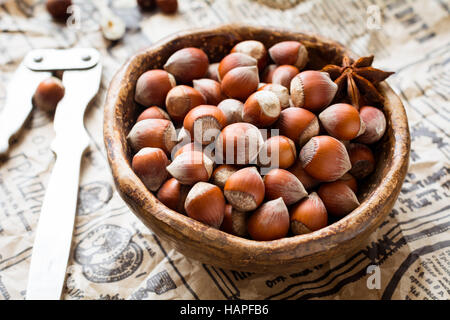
0;0;450;299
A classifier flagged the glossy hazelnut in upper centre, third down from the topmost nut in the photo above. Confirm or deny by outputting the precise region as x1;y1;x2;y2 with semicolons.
221;66;259;100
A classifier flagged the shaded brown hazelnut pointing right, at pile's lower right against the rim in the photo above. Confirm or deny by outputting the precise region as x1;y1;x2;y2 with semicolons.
317;181;359;218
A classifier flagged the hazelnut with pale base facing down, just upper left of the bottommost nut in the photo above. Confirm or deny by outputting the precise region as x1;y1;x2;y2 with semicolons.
224;167;265;212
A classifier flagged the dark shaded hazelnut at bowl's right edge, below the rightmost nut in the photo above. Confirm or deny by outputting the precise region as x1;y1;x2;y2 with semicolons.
347;143;375;180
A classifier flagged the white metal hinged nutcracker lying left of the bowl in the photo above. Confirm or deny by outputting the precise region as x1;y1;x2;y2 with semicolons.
0;48;102;299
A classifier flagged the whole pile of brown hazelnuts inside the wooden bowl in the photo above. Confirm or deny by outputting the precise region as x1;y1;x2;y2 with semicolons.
128;40;386;240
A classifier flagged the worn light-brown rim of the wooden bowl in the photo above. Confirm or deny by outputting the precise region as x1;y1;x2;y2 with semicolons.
104;24;409;262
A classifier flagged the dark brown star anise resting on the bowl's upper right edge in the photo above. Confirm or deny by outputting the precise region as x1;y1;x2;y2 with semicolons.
322;56;394;108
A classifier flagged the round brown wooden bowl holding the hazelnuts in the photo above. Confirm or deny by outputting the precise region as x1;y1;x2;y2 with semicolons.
104;25;410;272
